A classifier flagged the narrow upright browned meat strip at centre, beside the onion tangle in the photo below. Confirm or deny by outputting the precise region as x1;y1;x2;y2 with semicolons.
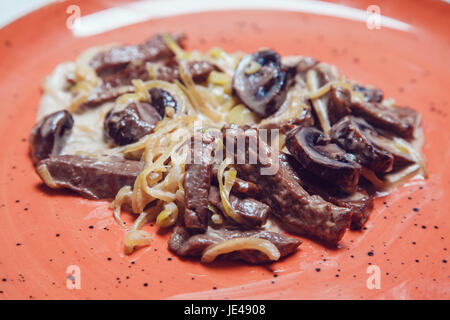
183;134;216;232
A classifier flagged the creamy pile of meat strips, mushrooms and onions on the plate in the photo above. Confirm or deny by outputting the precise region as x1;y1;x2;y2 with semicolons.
30;34;426;263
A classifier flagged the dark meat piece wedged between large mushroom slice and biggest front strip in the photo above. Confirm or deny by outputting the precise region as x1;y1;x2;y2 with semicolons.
281;154;373;229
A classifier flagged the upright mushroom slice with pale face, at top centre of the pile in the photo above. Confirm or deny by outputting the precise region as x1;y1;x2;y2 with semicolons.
233;50;287;117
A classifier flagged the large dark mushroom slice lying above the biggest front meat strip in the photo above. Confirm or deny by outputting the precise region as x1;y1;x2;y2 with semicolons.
286;127;361;192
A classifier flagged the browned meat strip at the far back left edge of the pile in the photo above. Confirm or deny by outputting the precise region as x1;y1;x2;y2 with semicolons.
90;34;185;76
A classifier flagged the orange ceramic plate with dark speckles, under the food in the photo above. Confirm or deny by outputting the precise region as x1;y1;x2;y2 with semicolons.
0;0;450;299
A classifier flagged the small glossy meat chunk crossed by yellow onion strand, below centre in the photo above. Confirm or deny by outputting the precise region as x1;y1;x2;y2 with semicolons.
208;186;270;228
